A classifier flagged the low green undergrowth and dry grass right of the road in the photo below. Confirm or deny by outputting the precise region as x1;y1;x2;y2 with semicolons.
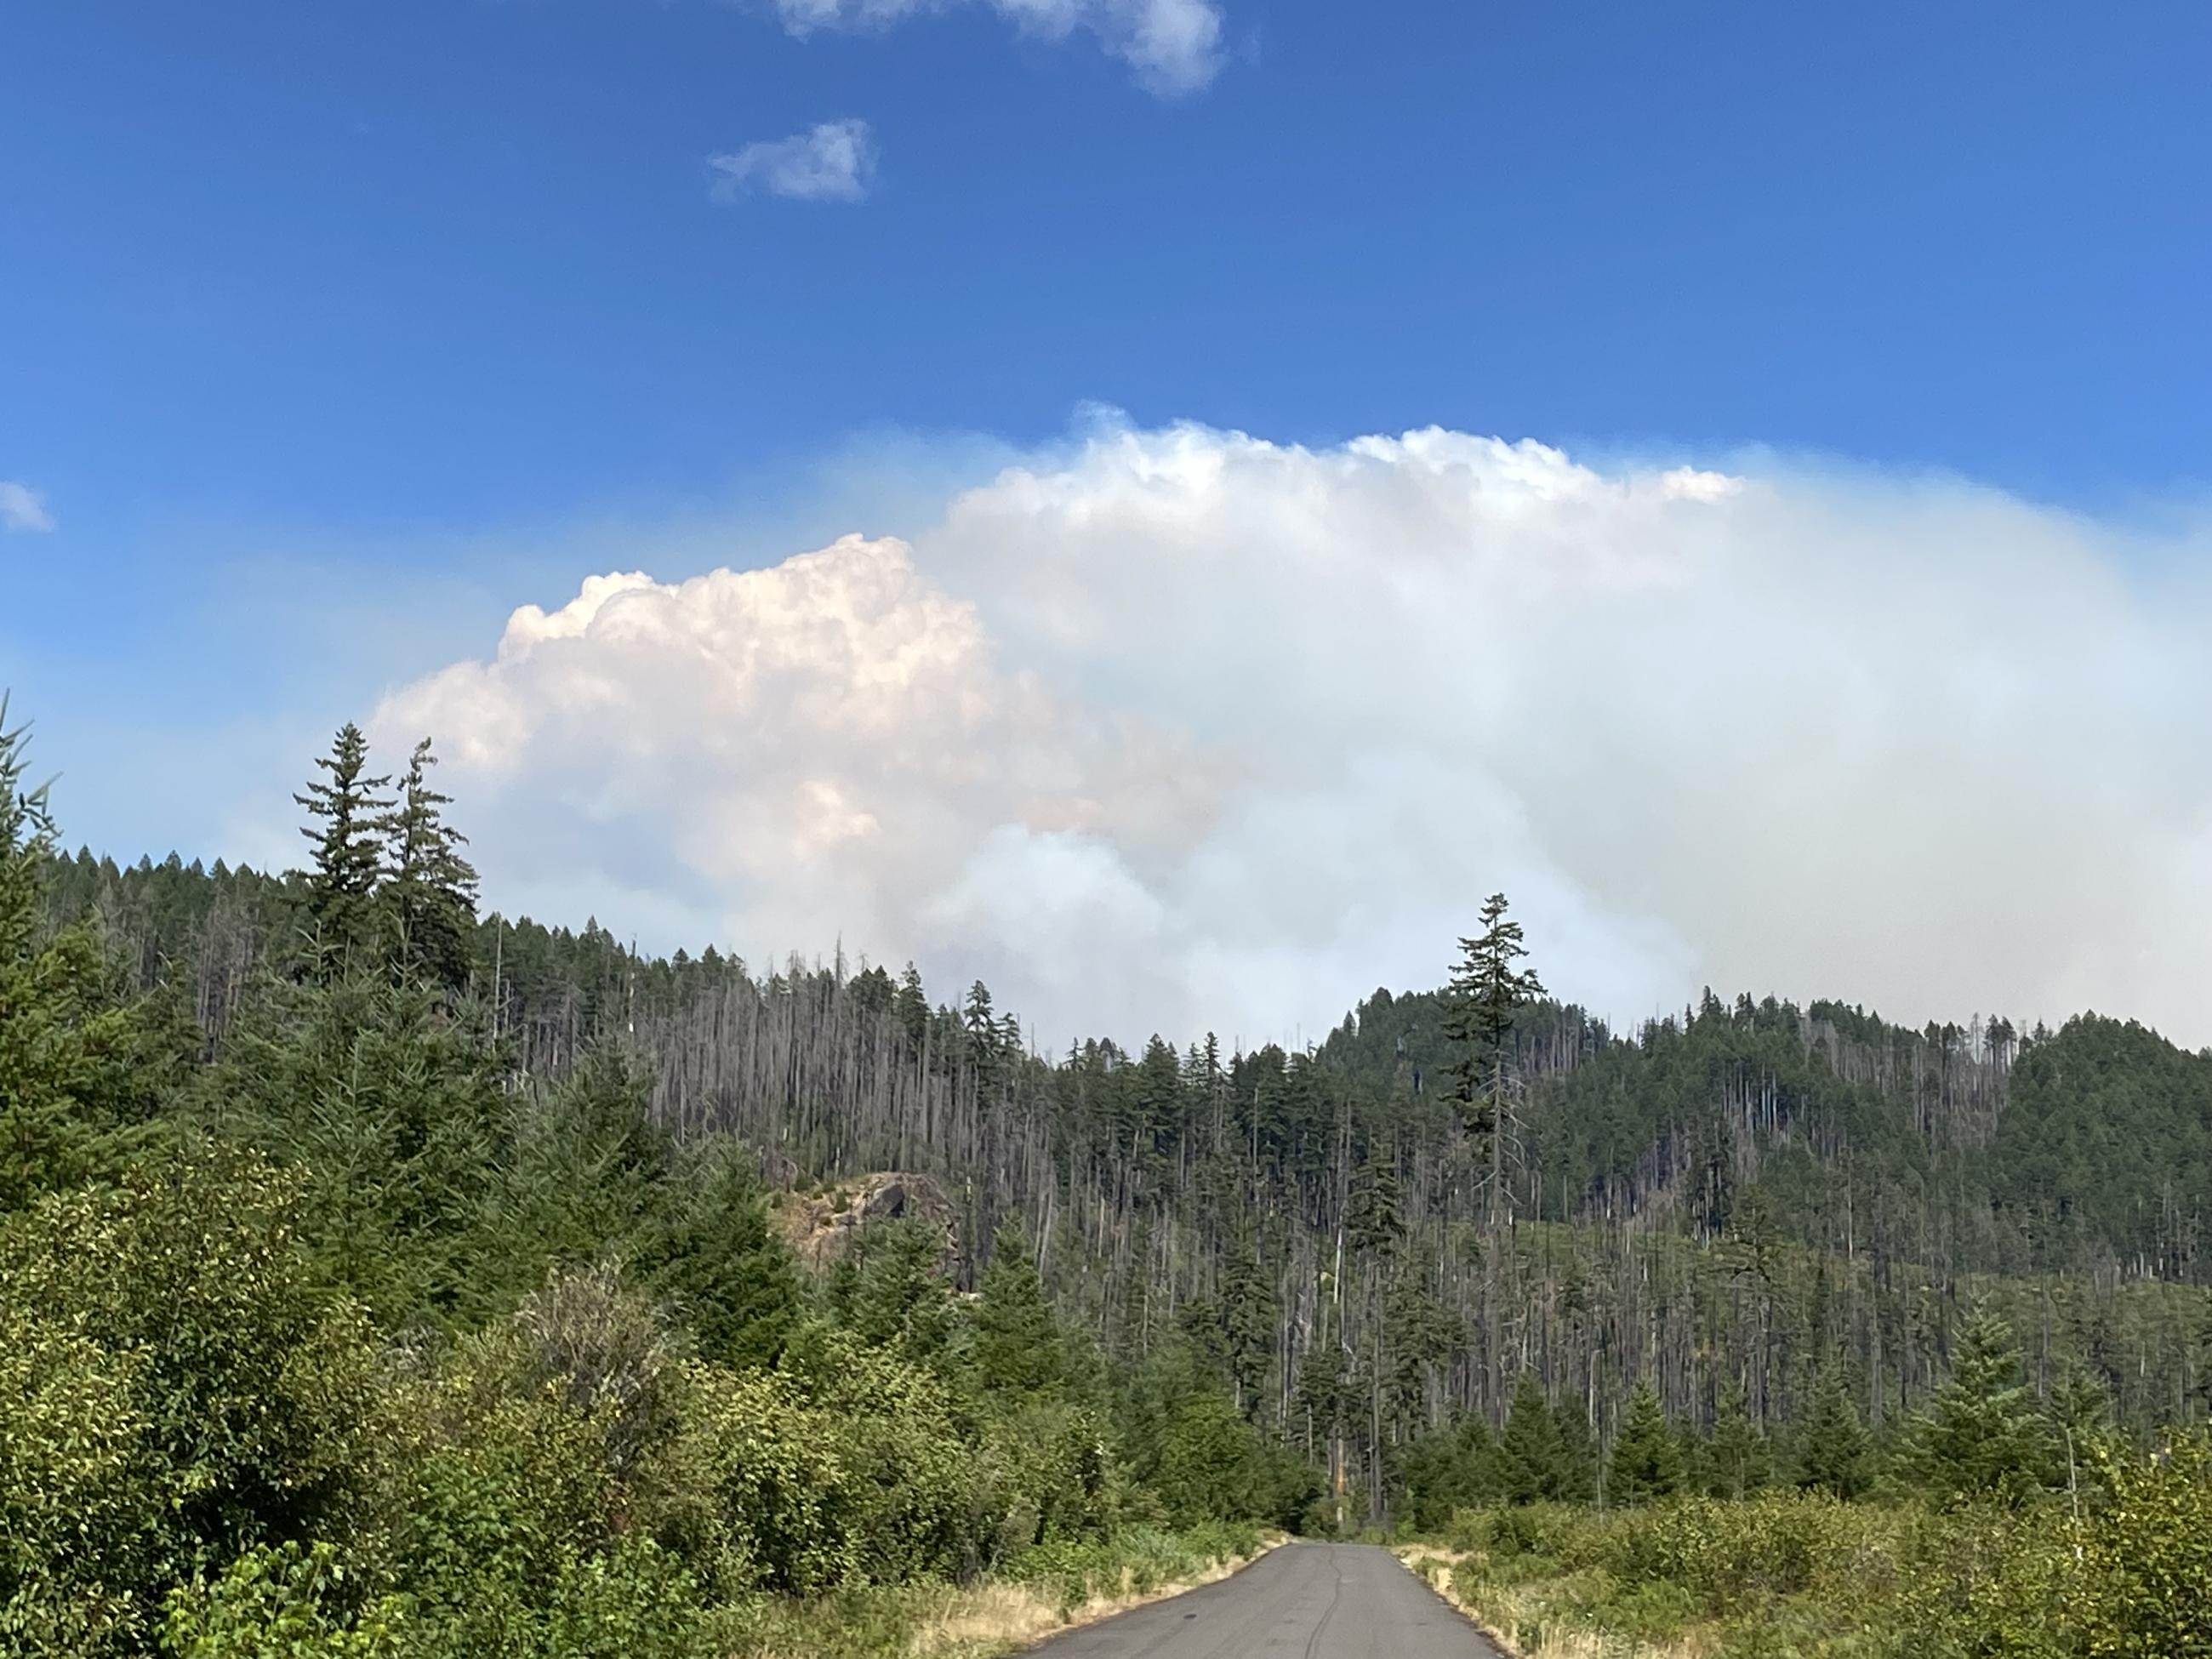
1416;1435;2212;1659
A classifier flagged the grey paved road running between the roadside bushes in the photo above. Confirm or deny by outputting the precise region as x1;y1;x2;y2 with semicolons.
1035;1544;1497;1659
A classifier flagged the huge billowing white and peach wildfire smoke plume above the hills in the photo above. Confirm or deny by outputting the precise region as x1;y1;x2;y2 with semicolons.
379;427;2212;1042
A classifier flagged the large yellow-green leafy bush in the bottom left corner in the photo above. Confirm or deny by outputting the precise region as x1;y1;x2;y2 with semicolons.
0;1154;376;1650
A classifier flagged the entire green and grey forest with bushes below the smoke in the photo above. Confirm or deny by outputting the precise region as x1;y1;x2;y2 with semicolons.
0;708;2212;1655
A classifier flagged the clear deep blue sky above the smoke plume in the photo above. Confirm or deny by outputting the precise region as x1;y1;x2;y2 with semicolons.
0;0;2212;1040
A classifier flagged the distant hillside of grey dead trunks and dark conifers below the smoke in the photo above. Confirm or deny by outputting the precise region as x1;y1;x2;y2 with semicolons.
48;765;2212;1477
